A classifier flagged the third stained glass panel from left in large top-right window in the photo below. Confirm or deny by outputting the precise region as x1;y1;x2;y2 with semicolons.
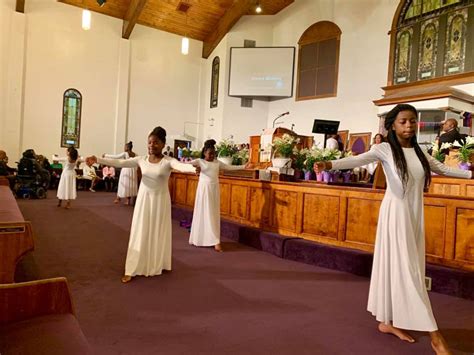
444;9;467;75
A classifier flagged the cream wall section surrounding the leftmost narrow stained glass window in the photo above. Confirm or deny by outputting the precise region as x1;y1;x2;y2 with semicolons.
22;0;122;159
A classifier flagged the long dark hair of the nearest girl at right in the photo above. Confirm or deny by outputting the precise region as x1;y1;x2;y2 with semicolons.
385;104;431;189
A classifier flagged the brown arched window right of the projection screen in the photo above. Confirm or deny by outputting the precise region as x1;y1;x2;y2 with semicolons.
296;21;341;101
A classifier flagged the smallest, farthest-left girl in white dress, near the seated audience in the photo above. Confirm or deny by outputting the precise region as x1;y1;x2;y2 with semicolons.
53;147;80;209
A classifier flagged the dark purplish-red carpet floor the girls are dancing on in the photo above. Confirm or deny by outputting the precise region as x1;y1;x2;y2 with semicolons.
17;191;474;355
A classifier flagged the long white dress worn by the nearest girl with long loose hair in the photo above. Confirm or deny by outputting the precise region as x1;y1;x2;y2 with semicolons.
332;143;471;331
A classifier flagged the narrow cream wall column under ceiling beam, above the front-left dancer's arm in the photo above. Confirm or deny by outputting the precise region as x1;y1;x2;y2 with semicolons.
113;38;130;153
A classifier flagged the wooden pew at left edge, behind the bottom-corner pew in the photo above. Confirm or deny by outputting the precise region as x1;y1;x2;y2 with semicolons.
0;186;34;284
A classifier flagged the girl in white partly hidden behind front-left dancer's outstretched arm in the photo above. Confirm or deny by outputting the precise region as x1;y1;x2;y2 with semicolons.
103;141;138;205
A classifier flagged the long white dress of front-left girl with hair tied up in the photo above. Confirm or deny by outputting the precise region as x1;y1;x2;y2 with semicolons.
97;156;195;276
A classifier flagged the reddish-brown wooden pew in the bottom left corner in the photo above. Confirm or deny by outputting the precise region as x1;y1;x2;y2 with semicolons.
0;277;92;355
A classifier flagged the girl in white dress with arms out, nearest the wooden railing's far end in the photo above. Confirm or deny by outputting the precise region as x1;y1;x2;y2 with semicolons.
189;139;245;251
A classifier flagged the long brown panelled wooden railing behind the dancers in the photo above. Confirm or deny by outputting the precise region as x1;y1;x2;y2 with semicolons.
170;172;474;270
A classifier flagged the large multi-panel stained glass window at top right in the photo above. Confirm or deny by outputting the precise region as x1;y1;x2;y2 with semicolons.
389;0;474;85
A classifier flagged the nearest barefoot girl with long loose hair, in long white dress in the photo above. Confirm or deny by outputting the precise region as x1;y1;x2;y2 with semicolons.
315;104;472;354
